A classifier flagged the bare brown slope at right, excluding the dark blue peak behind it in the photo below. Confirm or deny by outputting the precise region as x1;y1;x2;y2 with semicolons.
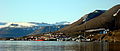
60;5;120;33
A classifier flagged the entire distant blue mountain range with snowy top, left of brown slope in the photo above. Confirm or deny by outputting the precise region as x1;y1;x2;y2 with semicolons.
0;22;67;38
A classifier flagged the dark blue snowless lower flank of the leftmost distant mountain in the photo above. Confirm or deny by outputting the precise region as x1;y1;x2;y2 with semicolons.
0;27;36;38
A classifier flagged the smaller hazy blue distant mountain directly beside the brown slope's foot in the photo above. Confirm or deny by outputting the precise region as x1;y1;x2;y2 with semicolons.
28;21;71;34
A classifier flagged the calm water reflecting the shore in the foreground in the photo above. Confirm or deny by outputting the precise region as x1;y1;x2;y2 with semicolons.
0;41;120;51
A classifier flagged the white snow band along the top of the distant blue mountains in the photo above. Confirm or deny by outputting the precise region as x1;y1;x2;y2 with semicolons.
0;21;71;28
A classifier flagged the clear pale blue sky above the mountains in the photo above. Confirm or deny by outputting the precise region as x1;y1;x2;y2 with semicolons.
0;0;120;23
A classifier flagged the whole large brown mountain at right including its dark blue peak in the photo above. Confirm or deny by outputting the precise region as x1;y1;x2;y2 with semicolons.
60;4;120;33
